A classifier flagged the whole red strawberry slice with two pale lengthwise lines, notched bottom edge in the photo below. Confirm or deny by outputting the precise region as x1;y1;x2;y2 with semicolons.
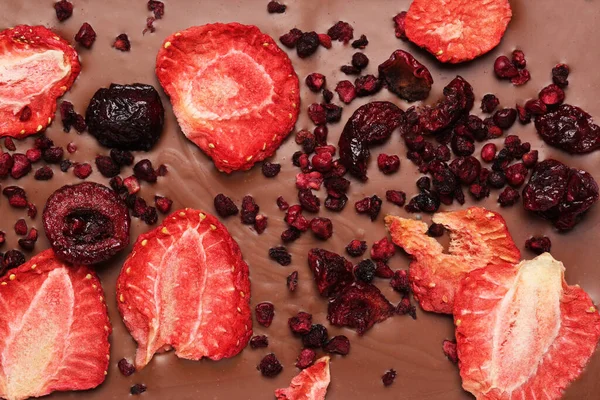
117;208;252;369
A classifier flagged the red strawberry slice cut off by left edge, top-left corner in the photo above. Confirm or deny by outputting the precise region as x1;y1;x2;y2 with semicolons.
0;25;81;137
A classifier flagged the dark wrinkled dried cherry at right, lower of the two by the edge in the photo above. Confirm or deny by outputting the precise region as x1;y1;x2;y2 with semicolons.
523;159;599;231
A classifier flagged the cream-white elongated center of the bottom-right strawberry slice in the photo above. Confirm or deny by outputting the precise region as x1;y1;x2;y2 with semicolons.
491;257;563;392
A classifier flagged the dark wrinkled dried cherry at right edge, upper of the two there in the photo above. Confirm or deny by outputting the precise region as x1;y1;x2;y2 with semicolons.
535;104;600;154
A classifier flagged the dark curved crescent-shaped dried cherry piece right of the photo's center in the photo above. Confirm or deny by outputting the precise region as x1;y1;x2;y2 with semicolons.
338;101;404;181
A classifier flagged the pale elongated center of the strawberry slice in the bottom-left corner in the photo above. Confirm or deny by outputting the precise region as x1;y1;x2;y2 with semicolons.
2;268;77;398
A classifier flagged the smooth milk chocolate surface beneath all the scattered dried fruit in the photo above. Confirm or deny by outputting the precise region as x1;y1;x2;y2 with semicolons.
0;0;600;400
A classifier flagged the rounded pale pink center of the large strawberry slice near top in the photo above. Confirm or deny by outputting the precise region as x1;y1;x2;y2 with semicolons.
188;50;273;120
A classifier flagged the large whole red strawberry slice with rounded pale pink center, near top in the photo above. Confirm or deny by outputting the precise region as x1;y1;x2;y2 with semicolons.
156;23;300;173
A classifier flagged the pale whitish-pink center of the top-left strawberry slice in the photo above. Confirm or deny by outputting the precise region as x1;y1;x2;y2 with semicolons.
0;50;71;114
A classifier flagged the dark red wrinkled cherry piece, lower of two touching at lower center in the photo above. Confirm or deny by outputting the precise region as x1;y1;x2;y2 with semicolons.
327;282;394;335
